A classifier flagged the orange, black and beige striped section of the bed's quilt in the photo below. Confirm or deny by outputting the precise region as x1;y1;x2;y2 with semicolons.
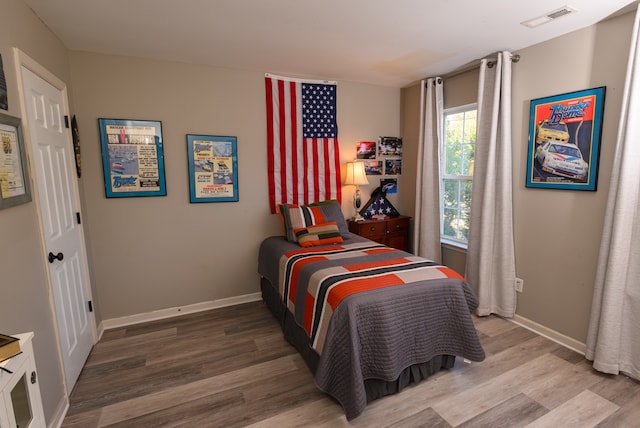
278;242;463;354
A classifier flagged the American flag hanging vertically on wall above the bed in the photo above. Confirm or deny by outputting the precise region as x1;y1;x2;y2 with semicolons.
264;74;341;213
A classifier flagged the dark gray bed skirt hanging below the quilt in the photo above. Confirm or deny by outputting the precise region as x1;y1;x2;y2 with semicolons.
260;277;455;402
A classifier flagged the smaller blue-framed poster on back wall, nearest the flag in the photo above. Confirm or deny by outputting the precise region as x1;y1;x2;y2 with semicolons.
187;134;238;203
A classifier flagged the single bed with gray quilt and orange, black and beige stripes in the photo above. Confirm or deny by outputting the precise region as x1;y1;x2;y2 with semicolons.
258;207;485;420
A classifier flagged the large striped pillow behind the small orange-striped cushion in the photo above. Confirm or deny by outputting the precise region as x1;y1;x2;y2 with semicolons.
278;201;351;242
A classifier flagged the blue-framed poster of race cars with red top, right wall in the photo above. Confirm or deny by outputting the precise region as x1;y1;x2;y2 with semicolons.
526;86;606;191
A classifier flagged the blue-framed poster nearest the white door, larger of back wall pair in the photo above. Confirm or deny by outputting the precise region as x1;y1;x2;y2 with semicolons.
98;119;167;198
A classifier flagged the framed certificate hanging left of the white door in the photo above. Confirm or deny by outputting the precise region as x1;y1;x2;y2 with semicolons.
0;113;31;209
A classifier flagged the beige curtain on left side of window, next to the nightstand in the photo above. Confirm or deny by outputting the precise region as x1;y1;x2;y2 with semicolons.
413;77;443;263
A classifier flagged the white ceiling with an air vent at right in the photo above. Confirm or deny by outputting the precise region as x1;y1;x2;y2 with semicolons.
23;0;635;87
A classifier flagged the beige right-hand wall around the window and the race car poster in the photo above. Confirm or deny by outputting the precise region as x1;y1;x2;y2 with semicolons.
401;13;633;343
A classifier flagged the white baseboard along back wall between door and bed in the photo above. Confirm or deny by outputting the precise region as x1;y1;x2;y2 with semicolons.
98;293;262;337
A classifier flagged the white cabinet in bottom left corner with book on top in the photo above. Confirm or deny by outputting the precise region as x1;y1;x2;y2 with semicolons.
0;333;45;428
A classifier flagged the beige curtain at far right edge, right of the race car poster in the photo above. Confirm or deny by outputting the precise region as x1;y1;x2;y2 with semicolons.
585;5;640;380
